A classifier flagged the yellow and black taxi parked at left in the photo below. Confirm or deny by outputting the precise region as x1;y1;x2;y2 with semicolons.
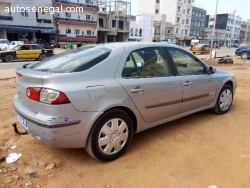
0;44;54;62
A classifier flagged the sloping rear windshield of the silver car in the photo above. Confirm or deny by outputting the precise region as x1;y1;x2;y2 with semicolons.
30;47;111;73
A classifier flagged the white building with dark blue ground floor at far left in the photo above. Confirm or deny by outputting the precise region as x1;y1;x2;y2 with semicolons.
0;0;55;42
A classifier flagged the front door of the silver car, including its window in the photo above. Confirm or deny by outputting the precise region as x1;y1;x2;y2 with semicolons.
167;47;218;112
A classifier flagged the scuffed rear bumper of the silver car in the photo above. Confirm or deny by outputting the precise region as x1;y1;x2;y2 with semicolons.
13;96;99;148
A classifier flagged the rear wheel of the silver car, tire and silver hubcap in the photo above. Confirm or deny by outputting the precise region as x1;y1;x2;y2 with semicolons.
85;109;133;161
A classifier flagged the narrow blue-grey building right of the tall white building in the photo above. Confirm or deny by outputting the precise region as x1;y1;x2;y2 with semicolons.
190;6;207;40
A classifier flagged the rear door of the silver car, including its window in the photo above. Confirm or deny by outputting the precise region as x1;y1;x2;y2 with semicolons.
116;47;182;122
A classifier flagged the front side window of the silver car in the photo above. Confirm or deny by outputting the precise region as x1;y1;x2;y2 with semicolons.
168;48;206;76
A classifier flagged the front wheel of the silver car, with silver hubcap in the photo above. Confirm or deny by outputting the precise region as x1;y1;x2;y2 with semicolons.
212;84;233;114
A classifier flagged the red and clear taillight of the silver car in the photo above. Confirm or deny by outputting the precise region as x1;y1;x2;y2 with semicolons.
26;87;70;105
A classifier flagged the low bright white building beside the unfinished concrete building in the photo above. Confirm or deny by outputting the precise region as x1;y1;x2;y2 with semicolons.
129;14;154;42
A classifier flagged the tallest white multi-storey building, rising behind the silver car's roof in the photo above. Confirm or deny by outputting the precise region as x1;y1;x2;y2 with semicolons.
138;0;193;45
